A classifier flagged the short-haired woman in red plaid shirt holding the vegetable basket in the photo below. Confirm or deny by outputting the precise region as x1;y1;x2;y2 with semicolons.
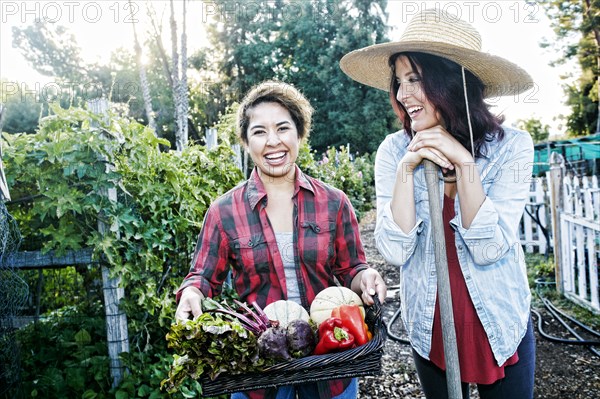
176;81;386;399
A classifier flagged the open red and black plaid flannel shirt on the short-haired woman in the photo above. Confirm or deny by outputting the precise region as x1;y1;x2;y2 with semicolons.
177;166;368;399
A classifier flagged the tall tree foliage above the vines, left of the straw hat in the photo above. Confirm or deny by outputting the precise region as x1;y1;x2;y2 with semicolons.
7;0;397;152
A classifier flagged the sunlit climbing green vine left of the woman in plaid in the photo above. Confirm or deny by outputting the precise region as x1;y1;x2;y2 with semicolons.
3;106;242;398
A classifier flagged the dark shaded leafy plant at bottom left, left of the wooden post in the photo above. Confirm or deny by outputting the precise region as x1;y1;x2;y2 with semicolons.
17;303;110;398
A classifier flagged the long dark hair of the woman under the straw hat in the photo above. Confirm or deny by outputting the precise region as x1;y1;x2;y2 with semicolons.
389;52;504;158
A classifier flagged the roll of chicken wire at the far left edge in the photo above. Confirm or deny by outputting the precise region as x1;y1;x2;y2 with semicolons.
0;198;29;395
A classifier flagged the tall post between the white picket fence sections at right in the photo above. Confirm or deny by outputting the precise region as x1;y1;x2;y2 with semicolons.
547;152;565;294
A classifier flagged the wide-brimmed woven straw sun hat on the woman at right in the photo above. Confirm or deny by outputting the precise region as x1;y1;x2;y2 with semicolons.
340;8;533;98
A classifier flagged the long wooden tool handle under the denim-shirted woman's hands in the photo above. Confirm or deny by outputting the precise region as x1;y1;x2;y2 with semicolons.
423;160;462;399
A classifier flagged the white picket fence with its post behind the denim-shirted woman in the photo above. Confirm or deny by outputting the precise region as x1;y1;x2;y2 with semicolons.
520;154;600;313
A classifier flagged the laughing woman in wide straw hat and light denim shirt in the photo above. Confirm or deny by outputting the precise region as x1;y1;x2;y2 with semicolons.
341;9;535;399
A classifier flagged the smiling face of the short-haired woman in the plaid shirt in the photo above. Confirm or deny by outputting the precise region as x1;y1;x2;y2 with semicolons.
247;102;300;182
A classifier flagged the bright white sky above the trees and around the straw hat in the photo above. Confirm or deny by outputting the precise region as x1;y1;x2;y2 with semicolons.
0;0;577;133
